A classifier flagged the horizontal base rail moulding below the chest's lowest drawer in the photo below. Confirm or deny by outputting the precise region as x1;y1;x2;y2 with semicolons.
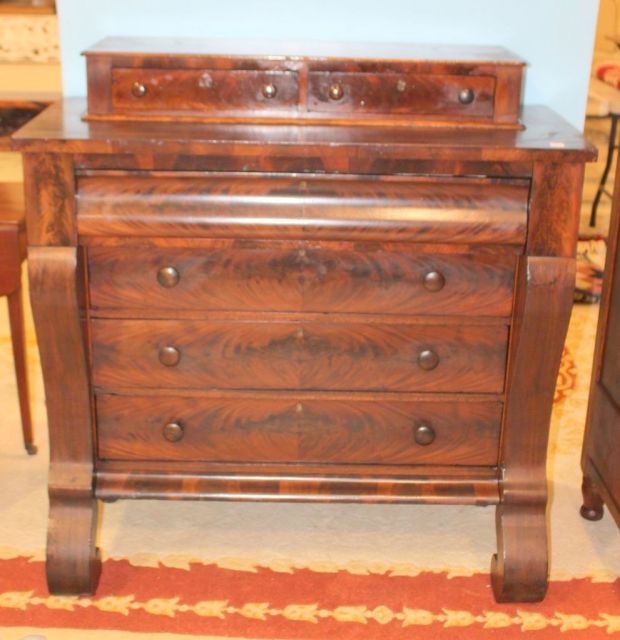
96;460;499;506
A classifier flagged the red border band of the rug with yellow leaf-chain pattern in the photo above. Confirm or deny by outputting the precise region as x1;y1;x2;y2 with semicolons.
0;558;620;640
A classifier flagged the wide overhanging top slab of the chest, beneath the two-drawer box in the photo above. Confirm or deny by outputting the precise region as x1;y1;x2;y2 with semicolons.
12;98;596;165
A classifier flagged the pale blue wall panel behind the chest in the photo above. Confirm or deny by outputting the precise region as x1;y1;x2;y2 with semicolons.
57;0;598;129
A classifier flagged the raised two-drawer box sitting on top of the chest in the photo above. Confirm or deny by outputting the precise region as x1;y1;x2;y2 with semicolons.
86;41;523;127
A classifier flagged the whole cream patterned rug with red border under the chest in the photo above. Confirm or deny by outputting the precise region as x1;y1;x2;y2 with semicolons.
0;292;620;640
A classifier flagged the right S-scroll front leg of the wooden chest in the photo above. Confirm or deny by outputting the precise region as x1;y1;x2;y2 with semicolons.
491;257;575;602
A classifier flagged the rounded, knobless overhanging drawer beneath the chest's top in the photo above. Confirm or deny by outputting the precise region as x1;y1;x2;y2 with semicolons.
77;174;529;245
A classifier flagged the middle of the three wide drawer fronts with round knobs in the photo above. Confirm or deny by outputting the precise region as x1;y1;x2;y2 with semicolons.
92;319;508;393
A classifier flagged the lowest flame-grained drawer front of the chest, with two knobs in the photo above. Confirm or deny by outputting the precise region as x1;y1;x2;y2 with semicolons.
97;395;502;465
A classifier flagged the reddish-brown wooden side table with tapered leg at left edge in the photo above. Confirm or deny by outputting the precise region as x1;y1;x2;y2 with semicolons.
0;183;37;455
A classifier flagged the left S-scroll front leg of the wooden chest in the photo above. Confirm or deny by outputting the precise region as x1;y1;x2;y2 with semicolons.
29;246;101;594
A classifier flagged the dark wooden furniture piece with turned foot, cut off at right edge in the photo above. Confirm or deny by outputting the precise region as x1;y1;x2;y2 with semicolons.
581;158;620;527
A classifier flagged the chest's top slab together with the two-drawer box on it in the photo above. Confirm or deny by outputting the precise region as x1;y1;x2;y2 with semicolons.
13;38;594;164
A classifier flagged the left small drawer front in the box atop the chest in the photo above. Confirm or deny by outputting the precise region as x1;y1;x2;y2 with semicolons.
112;69;299;112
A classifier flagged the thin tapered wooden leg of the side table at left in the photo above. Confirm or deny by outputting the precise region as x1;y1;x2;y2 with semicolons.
8;287;37;455
